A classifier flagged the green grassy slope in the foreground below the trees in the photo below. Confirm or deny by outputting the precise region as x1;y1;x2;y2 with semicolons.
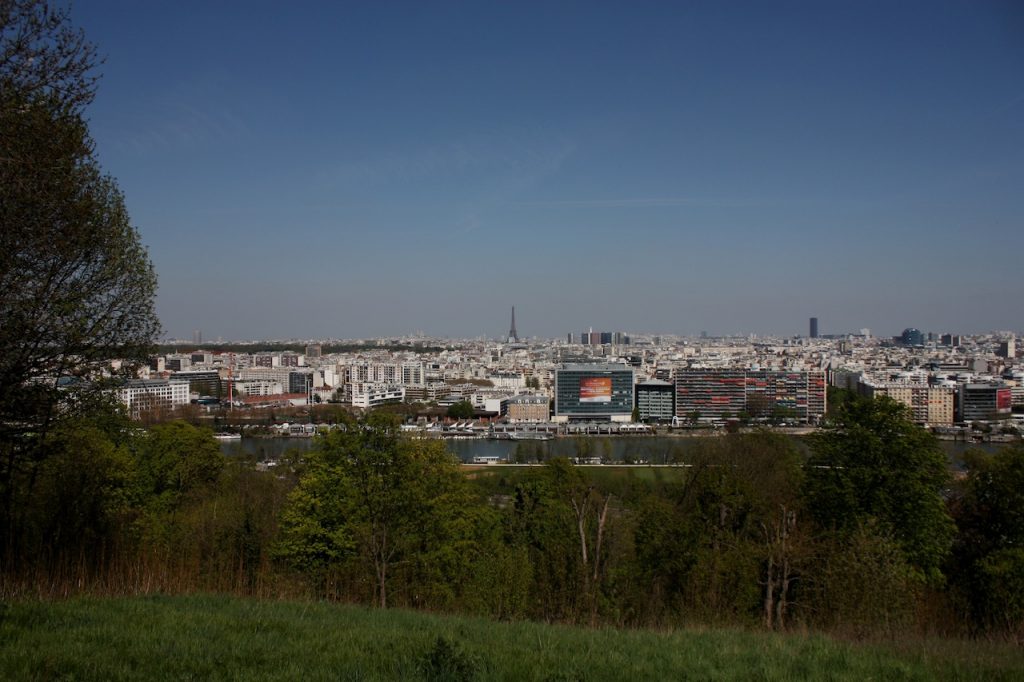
0;596;1024;680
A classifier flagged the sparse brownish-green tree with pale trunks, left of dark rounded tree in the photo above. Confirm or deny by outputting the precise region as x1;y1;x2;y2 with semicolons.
635;432;809;628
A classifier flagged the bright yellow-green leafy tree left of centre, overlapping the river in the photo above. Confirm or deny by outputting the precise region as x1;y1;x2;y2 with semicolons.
278;413;481;607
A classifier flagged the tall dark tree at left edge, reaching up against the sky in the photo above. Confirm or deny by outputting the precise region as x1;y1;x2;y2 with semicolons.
0;0;159;552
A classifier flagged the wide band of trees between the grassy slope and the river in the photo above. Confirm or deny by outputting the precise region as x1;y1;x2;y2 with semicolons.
3;398;1024;636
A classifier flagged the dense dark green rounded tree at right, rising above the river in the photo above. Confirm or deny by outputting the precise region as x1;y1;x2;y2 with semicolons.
804;397;953;581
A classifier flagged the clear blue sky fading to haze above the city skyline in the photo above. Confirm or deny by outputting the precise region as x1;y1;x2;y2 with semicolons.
73;0;1024;339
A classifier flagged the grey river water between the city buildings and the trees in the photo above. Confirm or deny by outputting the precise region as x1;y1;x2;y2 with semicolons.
221;436;999;465
